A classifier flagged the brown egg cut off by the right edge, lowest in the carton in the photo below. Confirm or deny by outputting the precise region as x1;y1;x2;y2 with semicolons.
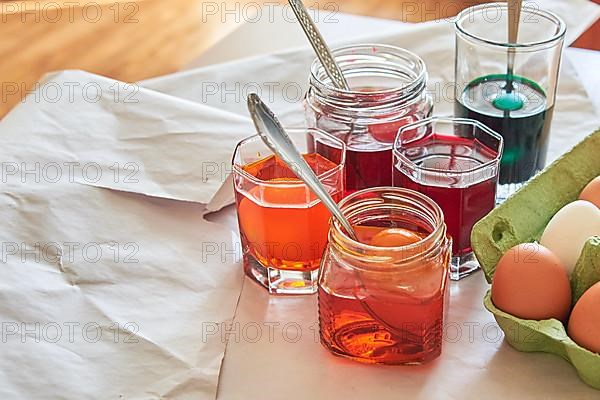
569;282;600;353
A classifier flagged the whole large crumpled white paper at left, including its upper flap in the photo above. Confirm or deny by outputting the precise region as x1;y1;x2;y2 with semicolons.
0;71;250;400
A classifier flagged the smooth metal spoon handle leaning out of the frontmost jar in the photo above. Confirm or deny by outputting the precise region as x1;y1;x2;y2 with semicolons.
248;93;358;241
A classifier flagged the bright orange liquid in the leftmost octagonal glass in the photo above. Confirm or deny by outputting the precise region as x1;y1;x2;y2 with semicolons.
236;154;342;272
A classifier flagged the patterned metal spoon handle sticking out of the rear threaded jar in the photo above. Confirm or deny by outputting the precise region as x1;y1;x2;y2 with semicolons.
288;0;350;90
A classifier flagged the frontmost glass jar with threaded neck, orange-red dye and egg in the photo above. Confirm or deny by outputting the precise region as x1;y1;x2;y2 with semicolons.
318;187;452;365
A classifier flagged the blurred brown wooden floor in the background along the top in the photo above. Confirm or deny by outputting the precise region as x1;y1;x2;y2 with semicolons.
0;0;600;117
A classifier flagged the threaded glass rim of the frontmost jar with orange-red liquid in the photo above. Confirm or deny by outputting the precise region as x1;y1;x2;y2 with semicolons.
331;186;446;260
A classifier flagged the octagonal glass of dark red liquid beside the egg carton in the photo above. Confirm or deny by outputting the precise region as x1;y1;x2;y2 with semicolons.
394;117;503;280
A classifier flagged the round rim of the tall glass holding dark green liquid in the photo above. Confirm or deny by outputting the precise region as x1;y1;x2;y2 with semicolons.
454;2;567;49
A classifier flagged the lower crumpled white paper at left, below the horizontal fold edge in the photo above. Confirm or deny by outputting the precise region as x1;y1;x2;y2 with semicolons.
0;180;241;400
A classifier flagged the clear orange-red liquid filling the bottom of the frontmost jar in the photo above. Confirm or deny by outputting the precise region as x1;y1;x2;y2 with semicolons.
319;287;444;364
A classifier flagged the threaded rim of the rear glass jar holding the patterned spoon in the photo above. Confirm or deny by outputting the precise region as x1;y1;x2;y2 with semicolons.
310;43;427;98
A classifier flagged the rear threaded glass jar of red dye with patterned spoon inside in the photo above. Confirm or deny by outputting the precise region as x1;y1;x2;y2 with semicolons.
305;44;433;193
